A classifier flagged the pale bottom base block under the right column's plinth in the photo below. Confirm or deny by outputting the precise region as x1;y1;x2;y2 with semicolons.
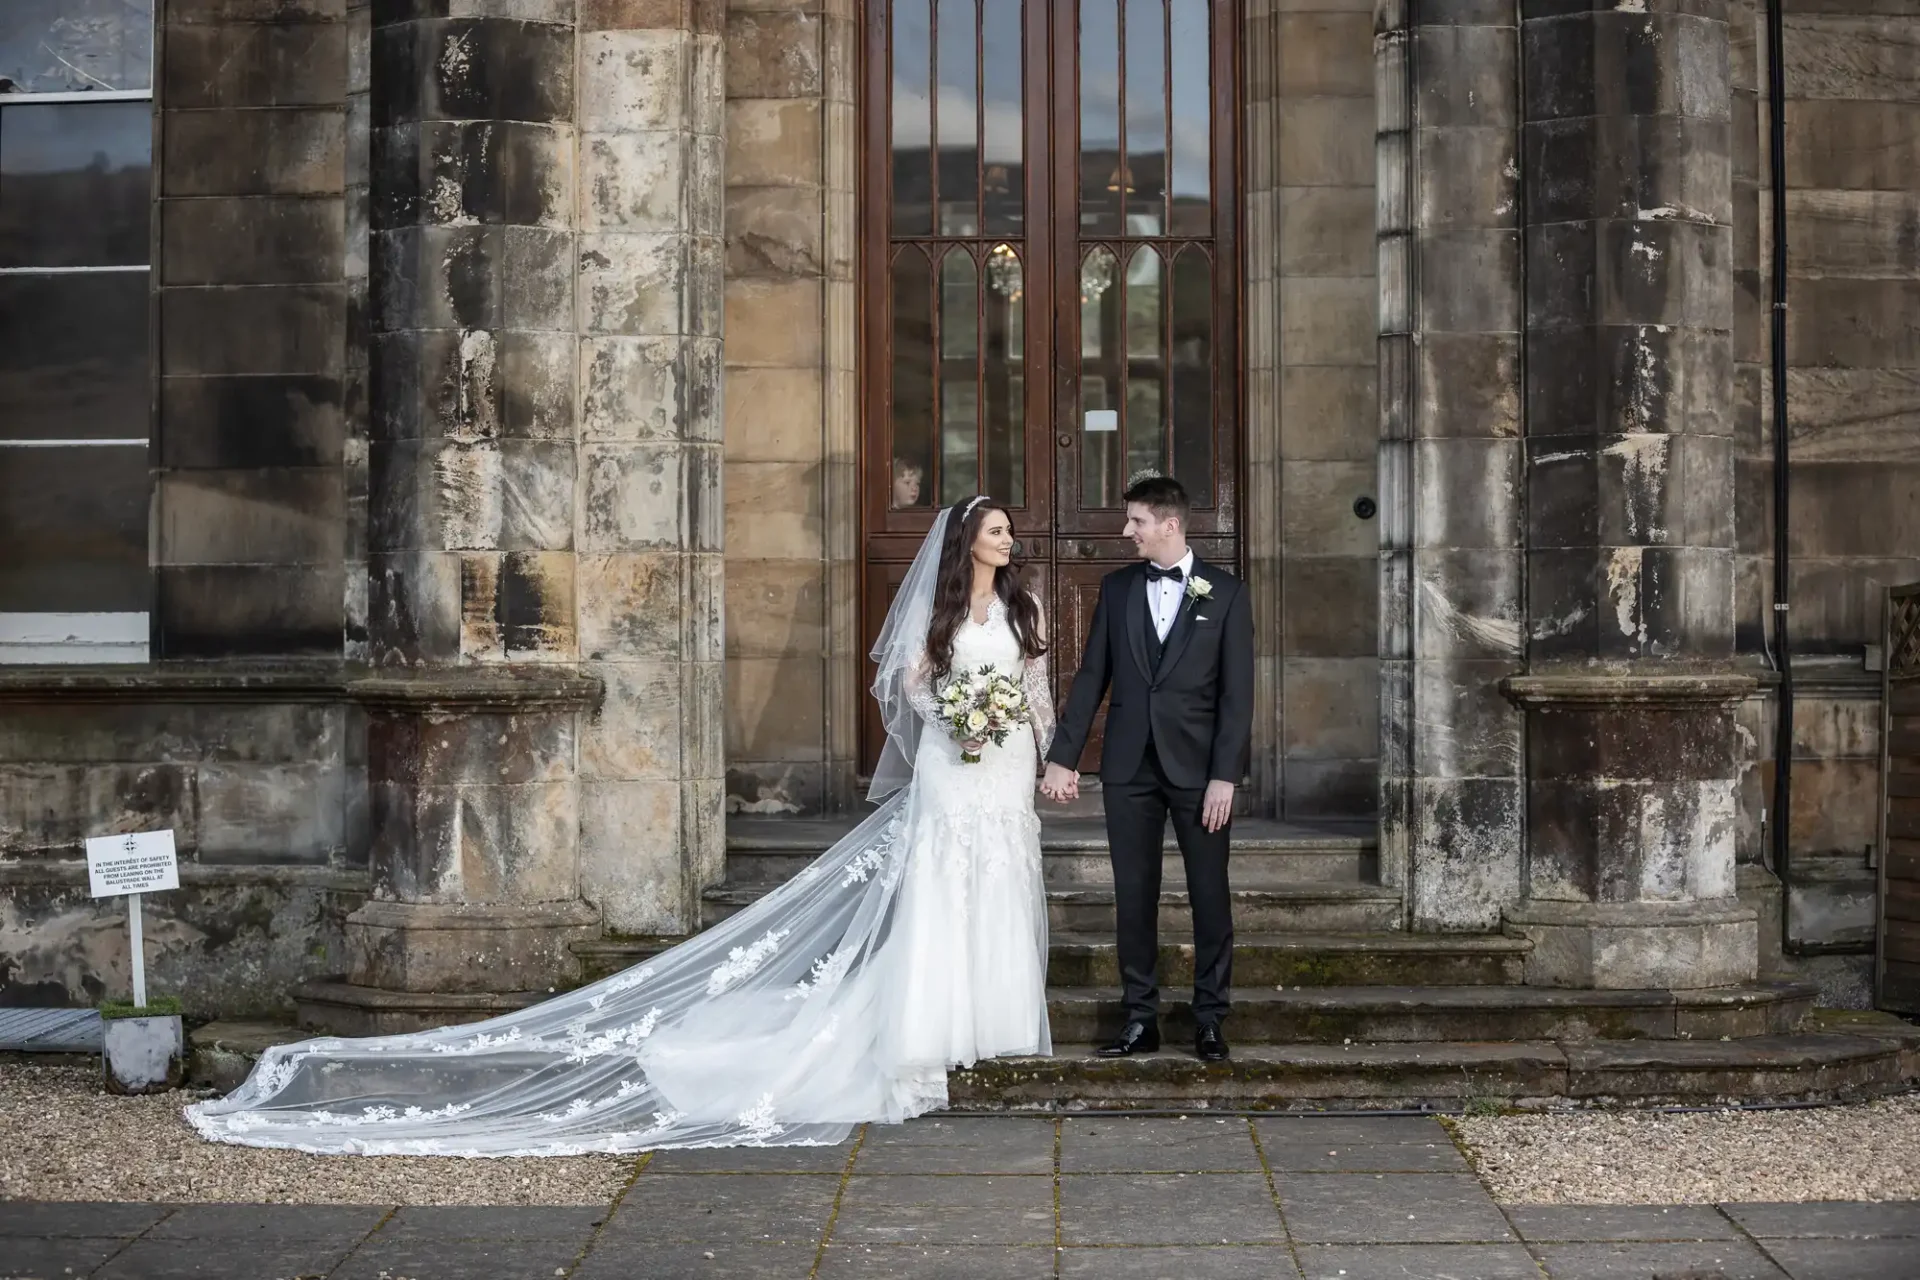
1505;898;1761;990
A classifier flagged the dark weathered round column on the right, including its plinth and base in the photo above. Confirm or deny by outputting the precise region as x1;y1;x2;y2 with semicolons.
1507;0;1757;988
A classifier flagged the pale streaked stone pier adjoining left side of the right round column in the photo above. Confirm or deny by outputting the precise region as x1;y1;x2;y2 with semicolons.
1377;0;1523;931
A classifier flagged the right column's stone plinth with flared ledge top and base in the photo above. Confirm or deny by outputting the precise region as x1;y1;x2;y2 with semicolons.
1505;672;1759;990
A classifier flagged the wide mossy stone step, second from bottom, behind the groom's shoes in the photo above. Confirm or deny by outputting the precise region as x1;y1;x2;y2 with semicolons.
1046;983;1818;1044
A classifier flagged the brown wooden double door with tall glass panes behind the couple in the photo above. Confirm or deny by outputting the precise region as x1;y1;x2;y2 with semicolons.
860;0;1240;768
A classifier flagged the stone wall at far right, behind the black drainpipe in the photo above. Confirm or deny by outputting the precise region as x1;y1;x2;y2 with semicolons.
1736;0;1920;1004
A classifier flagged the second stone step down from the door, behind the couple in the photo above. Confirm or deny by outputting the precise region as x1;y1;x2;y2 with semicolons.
701;881;1402;936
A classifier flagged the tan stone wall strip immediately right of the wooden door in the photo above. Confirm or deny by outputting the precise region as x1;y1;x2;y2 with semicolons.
1274;0;1380;818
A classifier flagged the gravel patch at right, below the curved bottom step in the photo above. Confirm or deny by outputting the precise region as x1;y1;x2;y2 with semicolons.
1452;1094;1920;1205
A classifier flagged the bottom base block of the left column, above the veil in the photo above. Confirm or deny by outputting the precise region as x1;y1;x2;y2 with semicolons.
346;900;599;994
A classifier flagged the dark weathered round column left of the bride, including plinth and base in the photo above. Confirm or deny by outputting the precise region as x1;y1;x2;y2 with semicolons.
301;0;599;1031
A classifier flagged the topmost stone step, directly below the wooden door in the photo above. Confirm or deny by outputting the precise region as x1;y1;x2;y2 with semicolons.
726;818;1379;889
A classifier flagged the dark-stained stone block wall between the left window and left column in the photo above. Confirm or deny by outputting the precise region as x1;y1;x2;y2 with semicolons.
152;0;348;658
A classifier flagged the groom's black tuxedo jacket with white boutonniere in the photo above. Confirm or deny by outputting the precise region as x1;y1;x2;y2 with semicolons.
1046;555;1254;787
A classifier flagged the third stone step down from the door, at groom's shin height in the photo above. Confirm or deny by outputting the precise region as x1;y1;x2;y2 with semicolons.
572;929;1532;986
